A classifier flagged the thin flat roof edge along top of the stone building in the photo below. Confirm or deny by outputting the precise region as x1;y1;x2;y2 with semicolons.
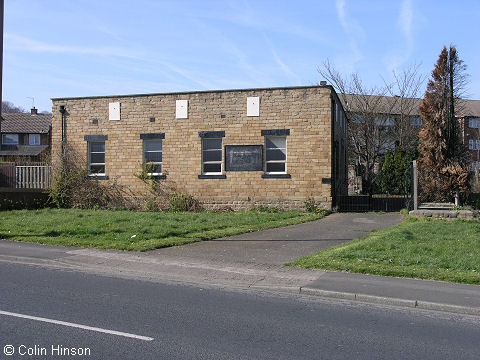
51;85;335;101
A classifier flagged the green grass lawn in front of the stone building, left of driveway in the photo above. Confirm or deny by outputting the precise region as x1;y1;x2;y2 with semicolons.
0;209;325;251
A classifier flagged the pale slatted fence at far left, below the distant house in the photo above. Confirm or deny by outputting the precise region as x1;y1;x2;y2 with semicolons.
0;164;52;189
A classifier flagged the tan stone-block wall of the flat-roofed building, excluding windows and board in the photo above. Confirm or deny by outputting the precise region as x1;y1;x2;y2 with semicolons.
52;86;346;209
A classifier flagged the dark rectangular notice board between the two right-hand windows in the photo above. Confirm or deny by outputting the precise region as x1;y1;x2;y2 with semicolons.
225;145;263;171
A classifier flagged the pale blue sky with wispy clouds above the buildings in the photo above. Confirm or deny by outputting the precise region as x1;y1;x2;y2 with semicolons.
3;0;480;111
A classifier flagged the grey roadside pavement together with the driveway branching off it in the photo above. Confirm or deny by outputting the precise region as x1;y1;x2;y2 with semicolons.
0;213;480;316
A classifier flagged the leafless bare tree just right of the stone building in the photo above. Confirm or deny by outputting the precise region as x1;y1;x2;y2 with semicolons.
318;60;422;193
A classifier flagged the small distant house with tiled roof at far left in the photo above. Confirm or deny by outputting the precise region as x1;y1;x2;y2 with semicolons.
0;108;52;164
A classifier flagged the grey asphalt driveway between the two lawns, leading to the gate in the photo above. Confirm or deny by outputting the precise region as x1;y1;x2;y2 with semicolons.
156;213;403;265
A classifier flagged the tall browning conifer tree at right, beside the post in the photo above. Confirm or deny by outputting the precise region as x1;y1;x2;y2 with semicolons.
418;46;469;201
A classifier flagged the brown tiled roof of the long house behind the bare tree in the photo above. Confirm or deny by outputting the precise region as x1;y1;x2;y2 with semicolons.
339;94;480;117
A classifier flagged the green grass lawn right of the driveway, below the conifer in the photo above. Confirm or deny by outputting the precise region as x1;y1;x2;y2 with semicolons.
288;218;480;284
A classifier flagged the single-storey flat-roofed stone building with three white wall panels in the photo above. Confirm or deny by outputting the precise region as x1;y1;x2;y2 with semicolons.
52;85;347;209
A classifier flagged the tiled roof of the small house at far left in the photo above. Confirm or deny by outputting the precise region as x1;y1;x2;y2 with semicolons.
1;113;52;134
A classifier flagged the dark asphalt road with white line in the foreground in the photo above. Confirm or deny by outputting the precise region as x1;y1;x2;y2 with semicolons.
0;262;480;360
